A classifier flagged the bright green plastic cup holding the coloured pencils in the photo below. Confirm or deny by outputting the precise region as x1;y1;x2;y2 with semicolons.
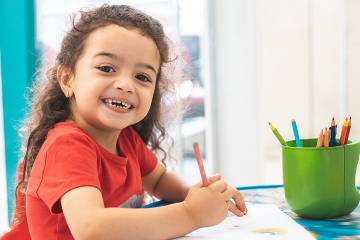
282;139;360;219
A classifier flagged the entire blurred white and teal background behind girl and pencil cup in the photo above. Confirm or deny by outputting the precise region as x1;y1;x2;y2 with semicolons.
0;0;360;228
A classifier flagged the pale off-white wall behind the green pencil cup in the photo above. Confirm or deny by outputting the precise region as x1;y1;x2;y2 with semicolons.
208;0;360;185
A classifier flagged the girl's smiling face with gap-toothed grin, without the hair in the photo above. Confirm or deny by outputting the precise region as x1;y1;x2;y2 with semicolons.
69;24;160;131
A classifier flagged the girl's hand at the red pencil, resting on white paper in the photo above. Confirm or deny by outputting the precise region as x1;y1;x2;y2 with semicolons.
183;176;246;228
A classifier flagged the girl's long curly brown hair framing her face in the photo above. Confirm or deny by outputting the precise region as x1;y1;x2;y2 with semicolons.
17;4;174;189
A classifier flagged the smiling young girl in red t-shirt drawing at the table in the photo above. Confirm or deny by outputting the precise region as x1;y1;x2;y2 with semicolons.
4;5;246;240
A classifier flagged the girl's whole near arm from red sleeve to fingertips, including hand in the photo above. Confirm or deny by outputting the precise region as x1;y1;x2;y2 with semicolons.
61;180;240;240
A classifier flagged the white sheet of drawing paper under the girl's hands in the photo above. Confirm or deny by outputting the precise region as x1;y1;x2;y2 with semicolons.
177;204;315;240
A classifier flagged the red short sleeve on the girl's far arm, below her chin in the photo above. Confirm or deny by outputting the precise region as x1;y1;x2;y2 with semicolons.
132;129;157;177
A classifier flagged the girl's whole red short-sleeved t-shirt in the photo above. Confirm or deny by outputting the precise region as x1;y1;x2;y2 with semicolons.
22;122;157;239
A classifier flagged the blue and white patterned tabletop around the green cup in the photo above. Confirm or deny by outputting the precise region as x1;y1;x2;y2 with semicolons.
145;185;360;240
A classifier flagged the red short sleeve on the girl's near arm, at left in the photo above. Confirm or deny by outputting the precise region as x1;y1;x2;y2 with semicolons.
37;134;100;213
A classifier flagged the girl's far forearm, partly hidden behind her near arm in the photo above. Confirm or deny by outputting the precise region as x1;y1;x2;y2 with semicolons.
142;162;189;202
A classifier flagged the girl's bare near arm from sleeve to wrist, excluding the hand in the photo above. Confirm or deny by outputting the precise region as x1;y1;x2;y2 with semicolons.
61;187;195;239
